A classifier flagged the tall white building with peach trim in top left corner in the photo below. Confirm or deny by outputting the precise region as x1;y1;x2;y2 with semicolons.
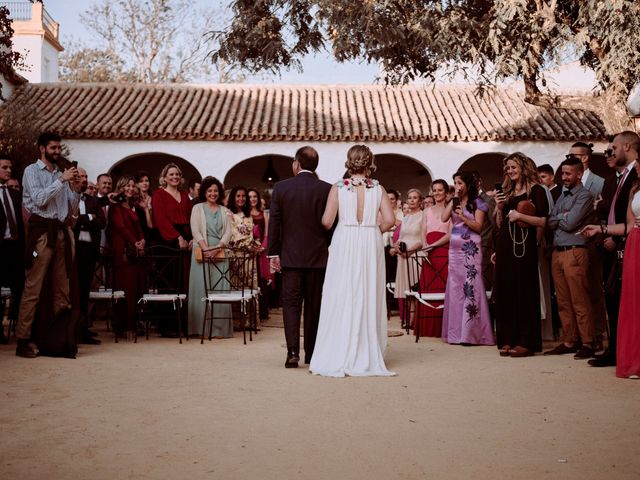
0;1;64;83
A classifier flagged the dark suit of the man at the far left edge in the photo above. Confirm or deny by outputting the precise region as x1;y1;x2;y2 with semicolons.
0;187;25;333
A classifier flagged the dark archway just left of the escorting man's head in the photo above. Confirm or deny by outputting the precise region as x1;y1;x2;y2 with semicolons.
223;154;293;193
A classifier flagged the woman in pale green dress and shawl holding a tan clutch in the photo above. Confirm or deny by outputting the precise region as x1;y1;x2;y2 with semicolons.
188;177;233;338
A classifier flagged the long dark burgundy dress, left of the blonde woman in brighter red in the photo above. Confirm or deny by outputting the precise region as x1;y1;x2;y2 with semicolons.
109;204;146;335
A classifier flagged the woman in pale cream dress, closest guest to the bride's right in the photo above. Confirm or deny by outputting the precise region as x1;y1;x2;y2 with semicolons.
389;188;422;324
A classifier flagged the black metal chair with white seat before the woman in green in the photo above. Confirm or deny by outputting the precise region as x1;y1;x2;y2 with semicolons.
200;248;260;345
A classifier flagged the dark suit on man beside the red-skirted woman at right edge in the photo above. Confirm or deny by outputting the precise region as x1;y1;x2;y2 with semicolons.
596;168;638;360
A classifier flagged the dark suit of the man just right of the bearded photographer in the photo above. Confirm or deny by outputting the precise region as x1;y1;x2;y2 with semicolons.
73;195;106;333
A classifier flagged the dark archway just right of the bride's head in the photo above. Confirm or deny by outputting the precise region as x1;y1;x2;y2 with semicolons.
373;153;432;199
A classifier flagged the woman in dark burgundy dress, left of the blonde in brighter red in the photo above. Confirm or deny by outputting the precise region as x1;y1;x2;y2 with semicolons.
109;175;145;339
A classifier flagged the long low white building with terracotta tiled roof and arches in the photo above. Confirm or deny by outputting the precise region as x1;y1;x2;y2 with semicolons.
10;84;607;191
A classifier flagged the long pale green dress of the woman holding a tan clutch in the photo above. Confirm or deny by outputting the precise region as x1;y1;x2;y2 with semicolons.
189;206;233;338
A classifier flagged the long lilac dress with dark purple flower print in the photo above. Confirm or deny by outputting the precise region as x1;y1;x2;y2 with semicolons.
442;198;494;345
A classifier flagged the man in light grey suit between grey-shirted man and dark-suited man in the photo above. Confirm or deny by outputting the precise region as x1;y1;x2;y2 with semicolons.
567;142;607;351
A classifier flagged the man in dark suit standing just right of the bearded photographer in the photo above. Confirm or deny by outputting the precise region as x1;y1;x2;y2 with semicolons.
73;168;106;345
